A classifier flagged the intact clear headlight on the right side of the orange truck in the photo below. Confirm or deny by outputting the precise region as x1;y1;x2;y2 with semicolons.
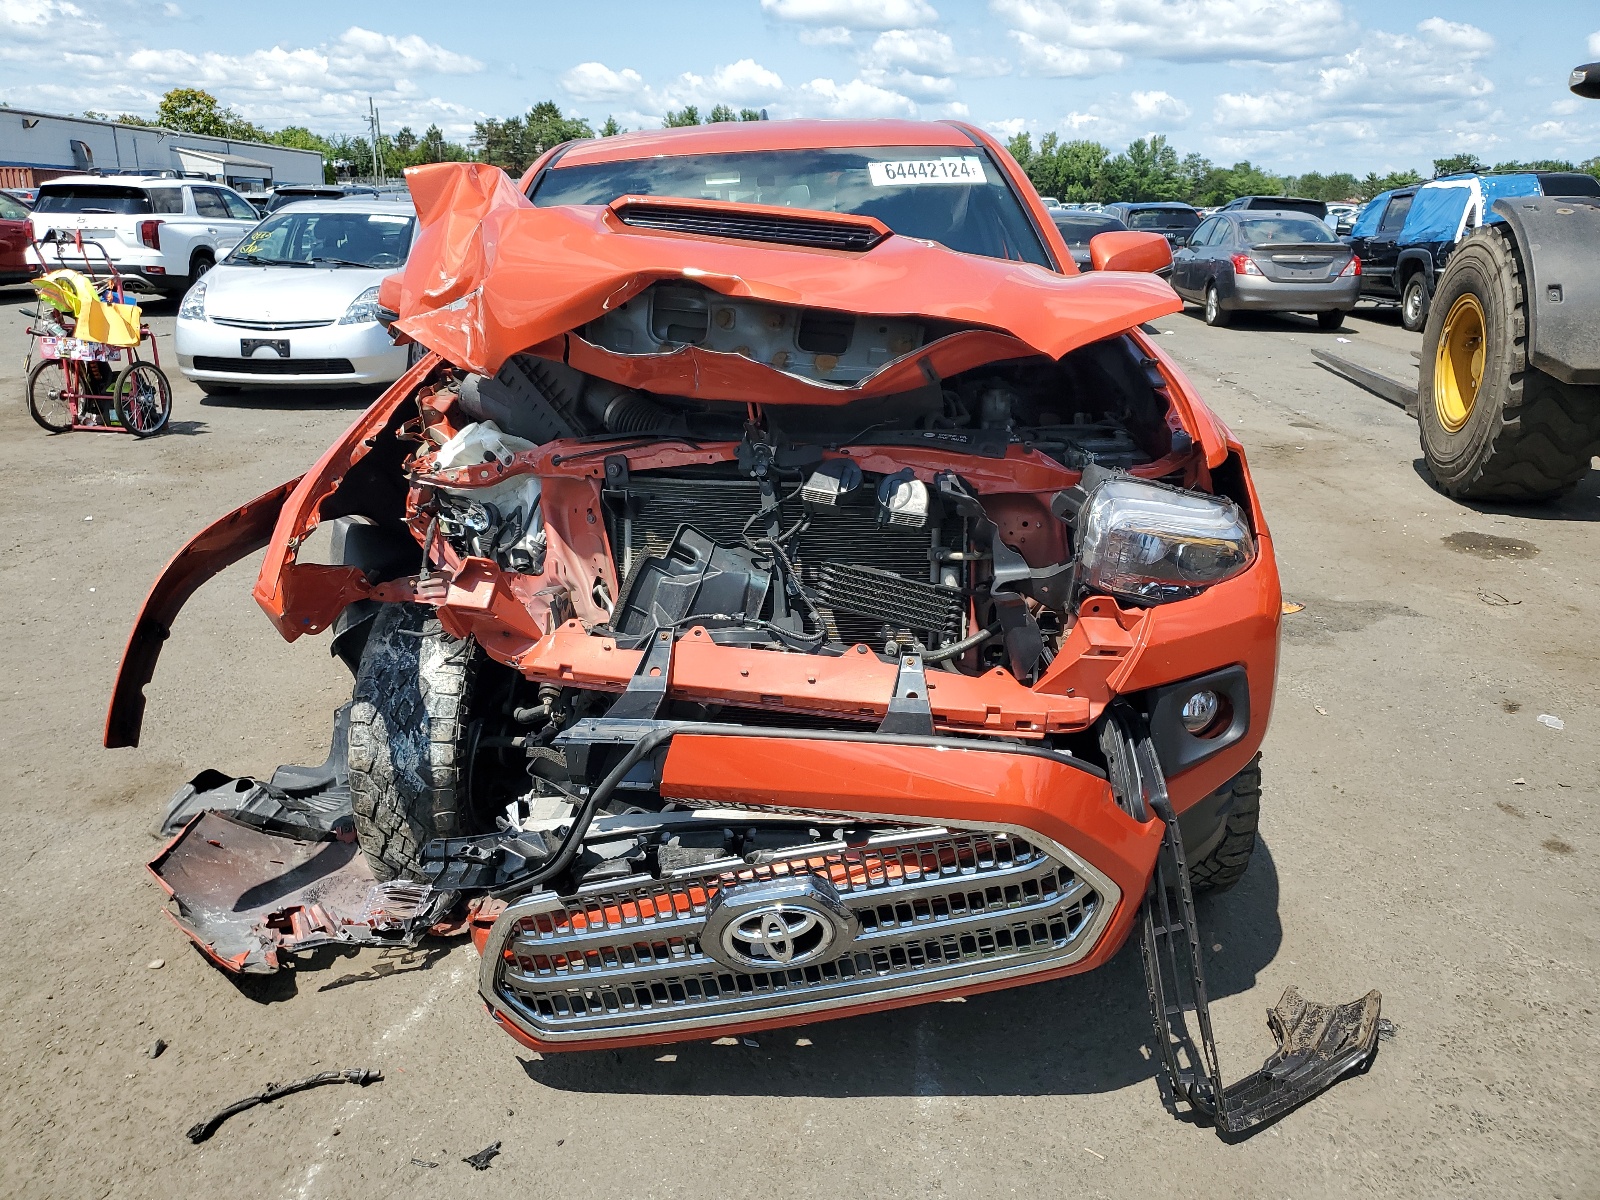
1077;478;1256;605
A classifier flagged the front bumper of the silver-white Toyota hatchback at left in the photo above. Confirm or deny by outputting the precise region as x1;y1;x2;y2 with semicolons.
176;318;406;387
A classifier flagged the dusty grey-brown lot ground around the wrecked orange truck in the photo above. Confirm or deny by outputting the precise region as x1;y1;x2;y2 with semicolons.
0;290;1600;1200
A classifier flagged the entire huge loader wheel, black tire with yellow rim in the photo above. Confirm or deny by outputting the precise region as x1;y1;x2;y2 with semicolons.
1416;226;1600;501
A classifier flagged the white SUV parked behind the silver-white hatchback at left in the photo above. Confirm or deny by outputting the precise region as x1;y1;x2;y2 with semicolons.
27;174;261;294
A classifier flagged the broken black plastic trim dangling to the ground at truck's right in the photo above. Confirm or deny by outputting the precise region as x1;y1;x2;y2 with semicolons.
1102;709;1382;1138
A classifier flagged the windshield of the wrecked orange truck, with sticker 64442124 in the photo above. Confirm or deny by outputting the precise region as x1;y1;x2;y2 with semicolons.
533;146;1051;267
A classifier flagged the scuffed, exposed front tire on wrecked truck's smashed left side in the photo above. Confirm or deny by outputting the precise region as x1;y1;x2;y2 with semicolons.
349;605;482;880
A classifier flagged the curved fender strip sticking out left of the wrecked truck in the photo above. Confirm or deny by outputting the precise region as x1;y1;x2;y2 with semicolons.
104;478;301;749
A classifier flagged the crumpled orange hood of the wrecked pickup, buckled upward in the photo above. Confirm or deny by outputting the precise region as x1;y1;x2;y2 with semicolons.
381;163;1182;374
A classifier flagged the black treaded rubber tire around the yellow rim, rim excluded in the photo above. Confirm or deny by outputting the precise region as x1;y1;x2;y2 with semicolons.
1418;226;1600;501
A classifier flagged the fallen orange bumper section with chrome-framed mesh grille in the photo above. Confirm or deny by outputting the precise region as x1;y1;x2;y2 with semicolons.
477;728;1162;1050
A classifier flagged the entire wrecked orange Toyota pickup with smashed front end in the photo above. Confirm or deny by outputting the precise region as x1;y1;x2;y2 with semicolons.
107;120;1378;1133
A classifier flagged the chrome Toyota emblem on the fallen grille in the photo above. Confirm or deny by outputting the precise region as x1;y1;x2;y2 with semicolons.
701;875;861;971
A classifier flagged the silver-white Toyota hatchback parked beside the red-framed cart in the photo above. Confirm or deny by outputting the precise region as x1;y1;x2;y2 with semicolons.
176;200;416;395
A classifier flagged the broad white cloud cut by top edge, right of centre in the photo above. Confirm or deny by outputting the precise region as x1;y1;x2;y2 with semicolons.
989;0;1354;64
